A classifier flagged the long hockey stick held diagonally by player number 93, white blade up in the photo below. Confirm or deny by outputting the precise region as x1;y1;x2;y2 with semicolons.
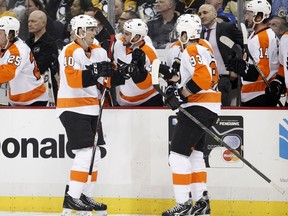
152;59;285;194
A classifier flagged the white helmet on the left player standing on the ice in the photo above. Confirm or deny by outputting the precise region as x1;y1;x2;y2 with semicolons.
70;14;98;38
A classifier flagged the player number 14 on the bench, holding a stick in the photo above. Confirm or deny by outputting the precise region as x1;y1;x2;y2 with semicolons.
226;0;286;107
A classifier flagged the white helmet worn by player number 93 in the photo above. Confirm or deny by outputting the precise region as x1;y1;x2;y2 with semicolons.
176;14;202;44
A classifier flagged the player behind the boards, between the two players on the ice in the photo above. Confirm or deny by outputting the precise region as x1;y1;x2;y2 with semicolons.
112;19;163;106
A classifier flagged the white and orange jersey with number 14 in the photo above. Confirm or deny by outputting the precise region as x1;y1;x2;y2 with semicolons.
241;28;280;102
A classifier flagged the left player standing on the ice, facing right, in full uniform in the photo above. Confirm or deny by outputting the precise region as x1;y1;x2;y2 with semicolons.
57;15;113;216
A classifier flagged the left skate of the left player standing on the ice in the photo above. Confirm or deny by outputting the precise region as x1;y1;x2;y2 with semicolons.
61;193;93;216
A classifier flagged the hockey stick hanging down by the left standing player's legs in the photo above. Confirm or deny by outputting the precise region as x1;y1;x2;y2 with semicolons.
87;87;107;182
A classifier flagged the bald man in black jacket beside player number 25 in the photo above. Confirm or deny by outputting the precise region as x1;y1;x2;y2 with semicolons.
26;10;59;102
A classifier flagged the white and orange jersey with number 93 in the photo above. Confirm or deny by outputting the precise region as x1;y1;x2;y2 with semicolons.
178;44;221;113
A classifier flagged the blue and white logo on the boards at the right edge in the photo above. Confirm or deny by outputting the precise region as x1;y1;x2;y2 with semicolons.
279;119;288;160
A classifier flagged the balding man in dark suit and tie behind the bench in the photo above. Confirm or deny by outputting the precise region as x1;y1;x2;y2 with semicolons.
198;4;243;106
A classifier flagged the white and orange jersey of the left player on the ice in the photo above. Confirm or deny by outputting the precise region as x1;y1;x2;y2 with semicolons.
57;42;109;116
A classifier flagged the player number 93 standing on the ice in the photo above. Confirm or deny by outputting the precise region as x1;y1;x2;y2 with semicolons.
159;12;221;216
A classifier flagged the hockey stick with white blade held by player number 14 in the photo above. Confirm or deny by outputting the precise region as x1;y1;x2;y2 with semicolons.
240;23;283;107
